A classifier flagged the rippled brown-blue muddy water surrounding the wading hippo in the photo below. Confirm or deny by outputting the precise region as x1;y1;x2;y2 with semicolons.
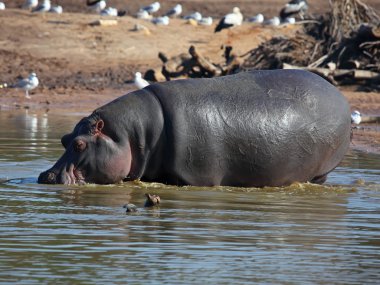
0;112;380;284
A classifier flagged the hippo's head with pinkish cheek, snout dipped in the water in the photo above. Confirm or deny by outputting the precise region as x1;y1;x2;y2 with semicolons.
38;117;131;184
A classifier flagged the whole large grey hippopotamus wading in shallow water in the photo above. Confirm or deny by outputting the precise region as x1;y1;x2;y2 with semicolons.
38;70;351;187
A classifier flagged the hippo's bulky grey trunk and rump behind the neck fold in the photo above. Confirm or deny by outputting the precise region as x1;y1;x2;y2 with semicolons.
148;70;350;186
